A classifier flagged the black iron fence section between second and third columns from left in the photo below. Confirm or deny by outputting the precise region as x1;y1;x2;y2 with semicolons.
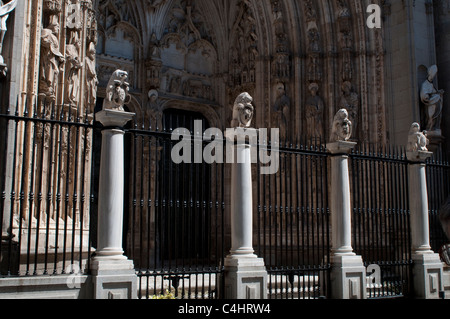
255;140;331;299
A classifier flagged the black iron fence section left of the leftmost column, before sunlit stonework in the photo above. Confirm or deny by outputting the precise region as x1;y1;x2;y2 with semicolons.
0;101;96;276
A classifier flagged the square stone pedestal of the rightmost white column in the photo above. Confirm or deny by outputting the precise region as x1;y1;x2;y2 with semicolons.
412;252;444;299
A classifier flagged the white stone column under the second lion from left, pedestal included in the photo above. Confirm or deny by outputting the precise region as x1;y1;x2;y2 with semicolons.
225;129;267;299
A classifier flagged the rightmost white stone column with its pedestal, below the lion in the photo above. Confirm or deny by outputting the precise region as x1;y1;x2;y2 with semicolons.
407;151;443;299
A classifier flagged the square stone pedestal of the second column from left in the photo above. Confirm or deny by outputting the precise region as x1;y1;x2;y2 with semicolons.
225;255;267;299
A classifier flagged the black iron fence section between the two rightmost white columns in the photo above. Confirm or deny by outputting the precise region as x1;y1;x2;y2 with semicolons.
350;145;412;298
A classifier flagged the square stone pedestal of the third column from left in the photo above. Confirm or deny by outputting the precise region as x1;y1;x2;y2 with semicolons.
331;255;367;299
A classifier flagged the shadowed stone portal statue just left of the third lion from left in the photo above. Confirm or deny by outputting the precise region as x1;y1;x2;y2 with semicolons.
306;83;324;137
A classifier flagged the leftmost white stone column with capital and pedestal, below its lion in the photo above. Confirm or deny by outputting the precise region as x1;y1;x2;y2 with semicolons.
91;110;137;299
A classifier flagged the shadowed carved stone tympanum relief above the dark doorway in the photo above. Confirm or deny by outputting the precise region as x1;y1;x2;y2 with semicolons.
157;0;217;101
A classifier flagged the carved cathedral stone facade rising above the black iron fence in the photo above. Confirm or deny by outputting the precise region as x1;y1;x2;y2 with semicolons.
3;0;450;145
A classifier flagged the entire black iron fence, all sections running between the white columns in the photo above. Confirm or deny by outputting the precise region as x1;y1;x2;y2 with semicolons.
0;99;450;299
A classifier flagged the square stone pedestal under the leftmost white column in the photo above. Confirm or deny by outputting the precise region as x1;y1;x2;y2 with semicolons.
91;257;138;299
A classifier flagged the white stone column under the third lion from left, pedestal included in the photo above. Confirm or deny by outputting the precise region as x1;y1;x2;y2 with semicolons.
327;141;367;299
